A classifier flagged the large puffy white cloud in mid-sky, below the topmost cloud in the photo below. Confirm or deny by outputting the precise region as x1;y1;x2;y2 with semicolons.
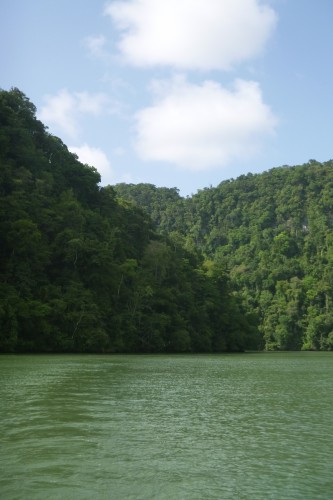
136;77;277;170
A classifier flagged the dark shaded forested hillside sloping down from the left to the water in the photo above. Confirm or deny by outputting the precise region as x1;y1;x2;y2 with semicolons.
0;89;260;352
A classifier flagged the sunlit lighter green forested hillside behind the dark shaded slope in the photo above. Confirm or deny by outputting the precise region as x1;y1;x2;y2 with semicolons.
115;160;333;350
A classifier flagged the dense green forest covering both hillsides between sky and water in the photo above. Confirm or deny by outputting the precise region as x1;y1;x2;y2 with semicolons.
0;89;333;352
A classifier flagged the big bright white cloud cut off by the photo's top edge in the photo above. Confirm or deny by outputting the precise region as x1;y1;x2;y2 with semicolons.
105;0;277;70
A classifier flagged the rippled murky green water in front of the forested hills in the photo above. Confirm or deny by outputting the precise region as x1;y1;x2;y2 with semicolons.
0;353;333;500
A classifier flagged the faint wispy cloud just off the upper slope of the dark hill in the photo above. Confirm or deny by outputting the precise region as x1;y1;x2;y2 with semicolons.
38;89;112;139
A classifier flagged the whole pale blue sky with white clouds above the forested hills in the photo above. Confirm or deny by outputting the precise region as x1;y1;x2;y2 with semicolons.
0;0;333;196
